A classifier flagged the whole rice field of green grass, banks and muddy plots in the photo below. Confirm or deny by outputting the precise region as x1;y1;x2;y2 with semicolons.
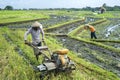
0;11;120;80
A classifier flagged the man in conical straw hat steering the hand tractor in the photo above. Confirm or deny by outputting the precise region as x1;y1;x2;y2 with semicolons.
24;21;44;60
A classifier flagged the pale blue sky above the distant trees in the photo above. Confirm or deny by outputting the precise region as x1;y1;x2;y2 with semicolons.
0;0;120;9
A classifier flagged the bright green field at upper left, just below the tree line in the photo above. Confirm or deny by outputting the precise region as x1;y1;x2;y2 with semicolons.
0;10;49;24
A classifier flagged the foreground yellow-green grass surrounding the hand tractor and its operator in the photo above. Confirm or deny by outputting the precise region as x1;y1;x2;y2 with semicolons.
0;28;119;80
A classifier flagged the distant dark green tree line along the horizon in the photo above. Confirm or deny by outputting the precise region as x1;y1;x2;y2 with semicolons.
0;4;120;12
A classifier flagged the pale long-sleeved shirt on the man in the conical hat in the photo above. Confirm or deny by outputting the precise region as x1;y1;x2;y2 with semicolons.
24;26;44;45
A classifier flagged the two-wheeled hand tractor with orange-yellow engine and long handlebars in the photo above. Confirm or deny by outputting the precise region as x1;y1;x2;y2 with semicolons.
25;42;76;80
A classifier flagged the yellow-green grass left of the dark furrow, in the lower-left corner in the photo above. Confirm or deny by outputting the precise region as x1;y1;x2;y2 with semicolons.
0;29;36;80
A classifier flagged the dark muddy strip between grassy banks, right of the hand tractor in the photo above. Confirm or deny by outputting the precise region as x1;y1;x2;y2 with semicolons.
56;37;120;76
